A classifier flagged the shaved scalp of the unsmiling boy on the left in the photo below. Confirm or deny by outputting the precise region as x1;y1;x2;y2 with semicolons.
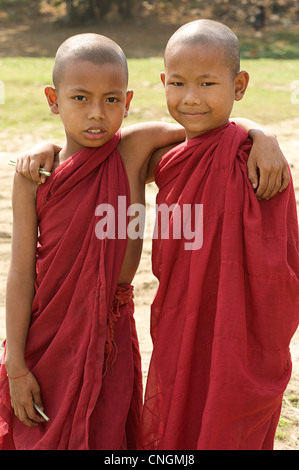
52;33;128;88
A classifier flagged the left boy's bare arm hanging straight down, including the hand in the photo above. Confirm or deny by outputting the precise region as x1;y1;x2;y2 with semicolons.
5;174;43;427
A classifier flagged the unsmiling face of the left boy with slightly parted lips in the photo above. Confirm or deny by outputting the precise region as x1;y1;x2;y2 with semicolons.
45;61;133;153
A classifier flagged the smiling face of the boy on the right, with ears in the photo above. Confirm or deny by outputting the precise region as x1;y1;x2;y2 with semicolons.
161;45;248;139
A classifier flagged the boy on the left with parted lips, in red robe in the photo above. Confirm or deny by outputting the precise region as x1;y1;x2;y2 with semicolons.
0;34;184;450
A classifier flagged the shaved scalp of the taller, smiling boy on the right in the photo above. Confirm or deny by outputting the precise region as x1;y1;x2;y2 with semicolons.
164;20;240;77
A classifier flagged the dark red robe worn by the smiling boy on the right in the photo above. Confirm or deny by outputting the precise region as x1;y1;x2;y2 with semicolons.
140;123;299;450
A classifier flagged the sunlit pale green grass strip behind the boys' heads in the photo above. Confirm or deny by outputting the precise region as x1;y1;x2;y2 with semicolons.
0;57;299;147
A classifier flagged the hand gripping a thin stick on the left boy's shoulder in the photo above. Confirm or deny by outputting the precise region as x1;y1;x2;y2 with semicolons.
16;142;60;184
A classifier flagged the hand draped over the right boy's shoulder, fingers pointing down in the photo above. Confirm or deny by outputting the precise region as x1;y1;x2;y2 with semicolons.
247;129;290;200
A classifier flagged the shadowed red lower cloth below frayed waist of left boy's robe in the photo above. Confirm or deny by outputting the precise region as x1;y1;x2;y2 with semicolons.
90;284;143;450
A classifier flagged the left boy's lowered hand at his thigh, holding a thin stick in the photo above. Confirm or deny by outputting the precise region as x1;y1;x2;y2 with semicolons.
9;372;45;428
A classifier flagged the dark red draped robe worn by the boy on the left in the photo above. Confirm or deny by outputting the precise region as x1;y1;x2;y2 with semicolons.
0;133;142;450
